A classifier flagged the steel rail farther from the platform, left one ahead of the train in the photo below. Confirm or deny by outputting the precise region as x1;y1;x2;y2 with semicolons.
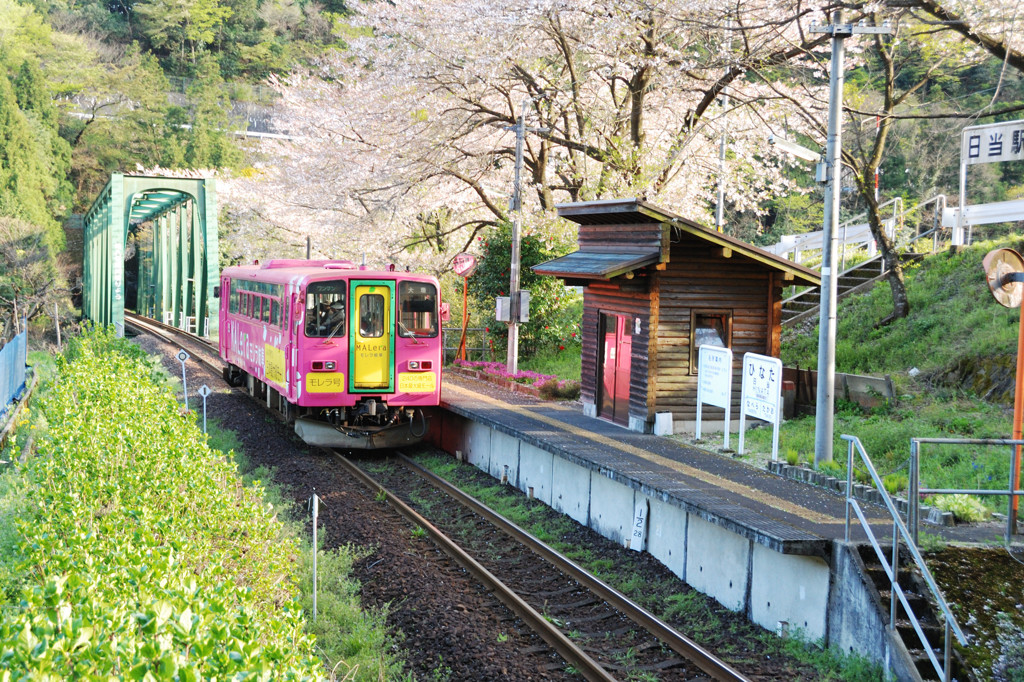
334;453;615;682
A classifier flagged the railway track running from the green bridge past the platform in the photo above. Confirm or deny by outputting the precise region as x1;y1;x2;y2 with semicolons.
126;315;761;682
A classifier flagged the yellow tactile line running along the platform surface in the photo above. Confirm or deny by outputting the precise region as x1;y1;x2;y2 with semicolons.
443;384;851;524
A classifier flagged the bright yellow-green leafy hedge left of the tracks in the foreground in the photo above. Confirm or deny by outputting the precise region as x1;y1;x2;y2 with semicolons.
0;333;321;680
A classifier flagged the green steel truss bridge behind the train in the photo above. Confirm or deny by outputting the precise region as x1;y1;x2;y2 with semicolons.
82;173;219;338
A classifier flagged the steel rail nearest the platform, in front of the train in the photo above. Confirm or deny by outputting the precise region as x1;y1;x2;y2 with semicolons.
398;453;750;682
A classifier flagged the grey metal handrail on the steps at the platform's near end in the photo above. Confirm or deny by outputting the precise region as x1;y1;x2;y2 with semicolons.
841;434;968;682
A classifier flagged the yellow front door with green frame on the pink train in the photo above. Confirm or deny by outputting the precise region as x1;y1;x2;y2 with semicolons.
348;280;394;393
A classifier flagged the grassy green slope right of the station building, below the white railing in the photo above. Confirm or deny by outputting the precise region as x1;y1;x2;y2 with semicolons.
733;237;1024;518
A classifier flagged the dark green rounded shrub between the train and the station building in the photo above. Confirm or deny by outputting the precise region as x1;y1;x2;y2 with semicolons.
469;224;583;357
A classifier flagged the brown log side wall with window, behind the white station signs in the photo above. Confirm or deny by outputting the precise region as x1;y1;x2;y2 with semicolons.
651;235;782;424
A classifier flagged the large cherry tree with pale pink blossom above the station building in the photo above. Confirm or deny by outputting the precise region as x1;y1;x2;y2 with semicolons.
224;0;847;270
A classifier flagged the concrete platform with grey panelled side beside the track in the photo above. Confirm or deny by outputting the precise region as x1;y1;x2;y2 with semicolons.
431;377;1003;678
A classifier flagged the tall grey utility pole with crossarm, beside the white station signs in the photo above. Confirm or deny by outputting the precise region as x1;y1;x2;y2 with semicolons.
811;14;890;466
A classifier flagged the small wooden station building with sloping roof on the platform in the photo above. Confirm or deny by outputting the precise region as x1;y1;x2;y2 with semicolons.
532;199;821;432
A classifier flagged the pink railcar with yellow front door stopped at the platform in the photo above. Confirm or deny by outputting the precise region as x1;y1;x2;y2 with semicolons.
218;260;446;450
